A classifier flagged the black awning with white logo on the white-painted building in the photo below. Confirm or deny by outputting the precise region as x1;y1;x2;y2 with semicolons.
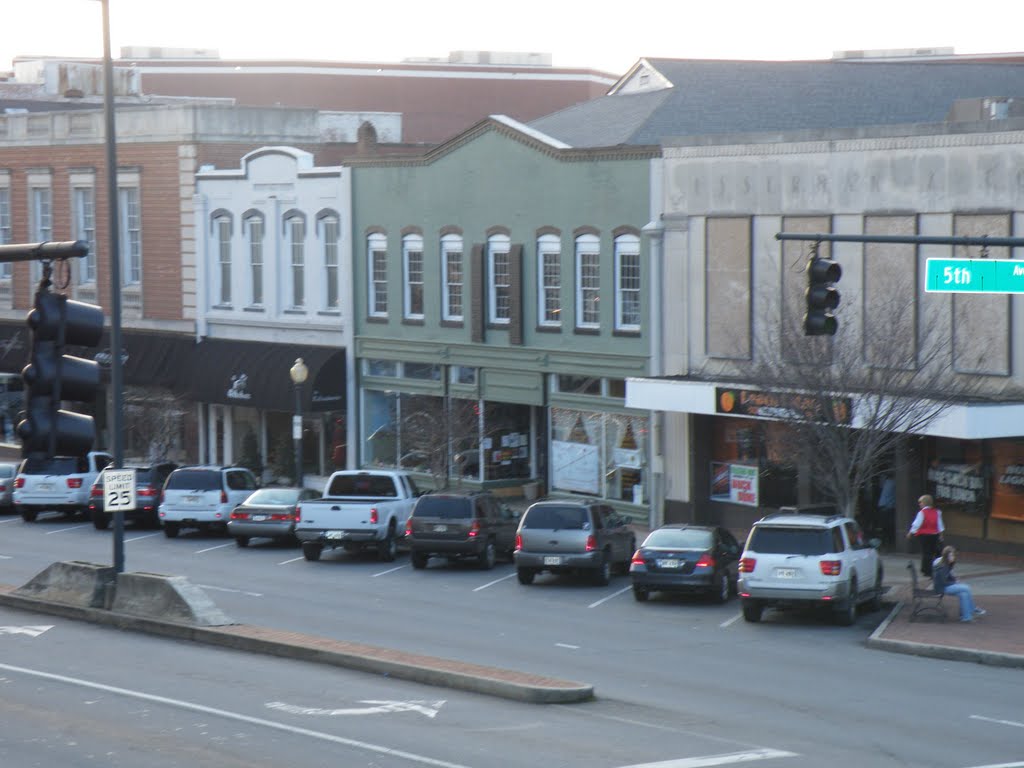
183;338;346;412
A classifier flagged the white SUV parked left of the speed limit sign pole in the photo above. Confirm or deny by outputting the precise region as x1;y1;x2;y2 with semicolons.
14;451;113;522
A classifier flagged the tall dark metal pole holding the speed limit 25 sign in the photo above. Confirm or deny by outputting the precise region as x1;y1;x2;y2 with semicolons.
99;0;125;573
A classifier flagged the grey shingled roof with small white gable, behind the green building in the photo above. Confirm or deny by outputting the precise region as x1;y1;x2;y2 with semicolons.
529;58;1024;147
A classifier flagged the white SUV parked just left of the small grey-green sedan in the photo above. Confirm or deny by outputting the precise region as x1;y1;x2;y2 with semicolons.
159;467;259;539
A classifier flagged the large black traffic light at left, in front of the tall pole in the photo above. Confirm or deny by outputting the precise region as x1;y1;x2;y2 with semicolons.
17;287;103;458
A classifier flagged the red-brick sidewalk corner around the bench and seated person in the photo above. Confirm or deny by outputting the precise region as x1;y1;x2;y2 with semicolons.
867;552;1024;668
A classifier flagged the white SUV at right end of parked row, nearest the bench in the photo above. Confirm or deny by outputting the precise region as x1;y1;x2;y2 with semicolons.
737;511;883;626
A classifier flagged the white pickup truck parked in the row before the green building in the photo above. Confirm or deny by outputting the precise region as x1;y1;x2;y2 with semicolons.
295;470;422;562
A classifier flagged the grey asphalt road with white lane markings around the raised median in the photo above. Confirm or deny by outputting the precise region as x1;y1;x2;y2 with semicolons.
0;516;1024;768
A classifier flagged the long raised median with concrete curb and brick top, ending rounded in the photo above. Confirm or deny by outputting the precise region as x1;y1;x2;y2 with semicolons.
0;586;594;703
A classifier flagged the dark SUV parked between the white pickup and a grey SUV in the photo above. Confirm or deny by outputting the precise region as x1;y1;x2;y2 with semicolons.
406;490;518;568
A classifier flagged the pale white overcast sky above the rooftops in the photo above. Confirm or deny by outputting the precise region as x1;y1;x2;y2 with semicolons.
6;0;1024;75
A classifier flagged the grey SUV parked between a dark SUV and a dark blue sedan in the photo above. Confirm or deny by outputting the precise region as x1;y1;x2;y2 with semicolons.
514;500;637;586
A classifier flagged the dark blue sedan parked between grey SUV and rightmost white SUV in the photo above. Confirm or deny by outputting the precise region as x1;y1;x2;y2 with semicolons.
630;524;740;603
